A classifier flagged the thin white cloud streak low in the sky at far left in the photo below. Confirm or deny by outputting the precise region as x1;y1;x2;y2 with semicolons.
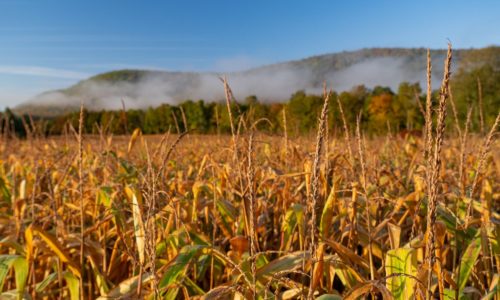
0;65;89;79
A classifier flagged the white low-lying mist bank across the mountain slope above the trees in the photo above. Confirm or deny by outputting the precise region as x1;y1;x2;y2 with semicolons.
22;57;443;110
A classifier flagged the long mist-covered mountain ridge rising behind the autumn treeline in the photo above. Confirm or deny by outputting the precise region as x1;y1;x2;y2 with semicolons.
14;46;500;115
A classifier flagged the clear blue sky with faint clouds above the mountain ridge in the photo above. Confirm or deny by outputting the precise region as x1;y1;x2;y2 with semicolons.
0;0;500;109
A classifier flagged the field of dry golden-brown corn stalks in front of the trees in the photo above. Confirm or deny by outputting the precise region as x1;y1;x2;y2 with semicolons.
0;47;500;300
